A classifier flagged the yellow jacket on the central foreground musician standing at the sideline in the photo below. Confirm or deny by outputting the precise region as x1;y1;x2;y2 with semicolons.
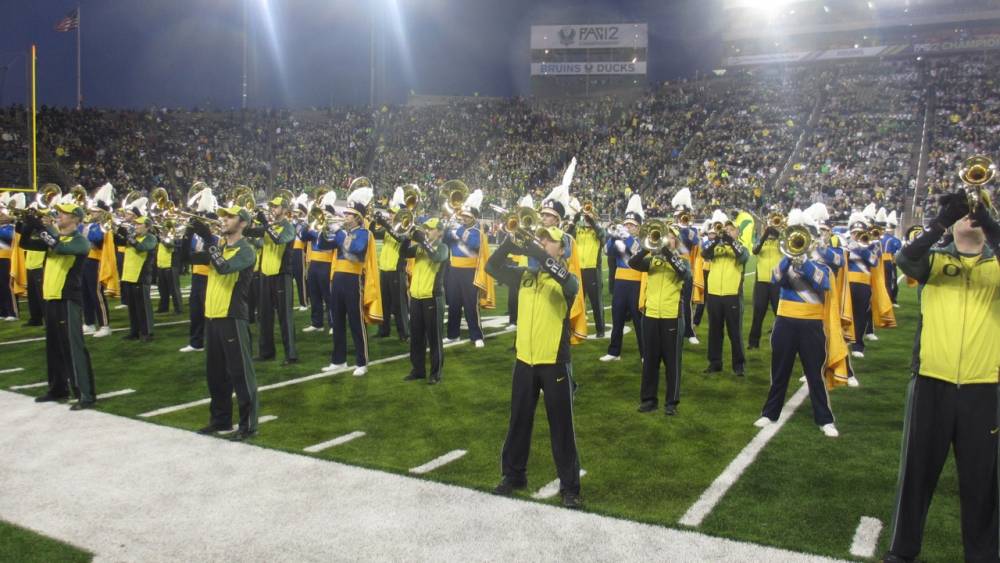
486;244;580;366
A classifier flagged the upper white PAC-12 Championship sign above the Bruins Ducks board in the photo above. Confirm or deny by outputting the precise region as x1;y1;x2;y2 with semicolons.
531;23;648;49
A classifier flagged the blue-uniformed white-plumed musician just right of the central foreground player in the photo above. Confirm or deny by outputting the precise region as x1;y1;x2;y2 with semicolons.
600;194;645;362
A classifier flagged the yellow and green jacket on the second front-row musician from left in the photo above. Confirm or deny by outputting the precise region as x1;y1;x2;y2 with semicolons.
191;238;257;320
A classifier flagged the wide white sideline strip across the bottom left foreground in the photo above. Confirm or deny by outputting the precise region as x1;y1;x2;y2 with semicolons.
0;392;844;563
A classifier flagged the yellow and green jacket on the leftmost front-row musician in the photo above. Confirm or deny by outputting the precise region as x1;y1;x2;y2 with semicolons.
21;228;90;305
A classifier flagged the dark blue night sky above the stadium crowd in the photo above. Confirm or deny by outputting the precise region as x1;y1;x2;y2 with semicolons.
0;0;722;109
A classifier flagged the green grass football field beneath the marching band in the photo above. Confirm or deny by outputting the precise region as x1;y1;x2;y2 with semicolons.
0;267;962;561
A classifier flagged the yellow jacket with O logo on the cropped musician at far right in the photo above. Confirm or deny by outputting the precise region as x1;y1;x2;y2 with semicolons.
896;244;1000;385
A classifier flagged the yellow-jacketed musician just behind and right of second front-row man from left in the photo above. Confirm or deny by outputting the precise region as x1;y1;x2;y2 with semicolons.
243;191;299;366
